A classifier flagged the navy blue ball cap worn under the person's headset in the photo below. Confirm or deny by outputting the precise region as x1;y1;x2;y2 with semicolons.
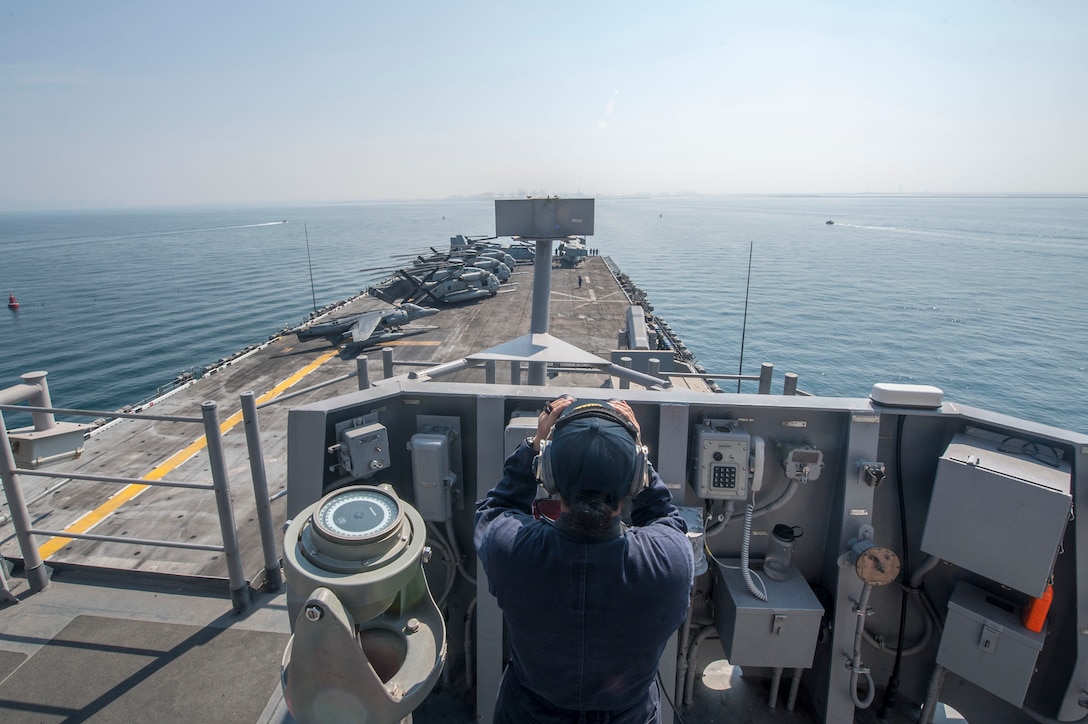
548;401;638;507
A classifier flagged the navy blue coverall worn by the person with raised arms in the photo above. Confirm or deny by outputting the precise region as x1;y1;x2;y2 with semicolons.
474;442;693;724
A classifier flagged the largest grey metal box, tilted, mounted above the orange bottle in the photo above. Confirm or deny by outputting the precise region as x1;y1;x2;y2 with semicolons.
922;429;1073;597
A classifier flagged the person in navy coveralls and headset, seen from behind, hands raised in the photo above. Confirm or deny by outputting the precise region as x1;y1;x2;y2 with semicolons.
474;397;693;724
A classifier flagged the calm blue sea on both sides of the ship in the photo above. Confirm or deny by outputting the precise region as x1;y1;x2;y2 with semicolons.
0;196;1088;432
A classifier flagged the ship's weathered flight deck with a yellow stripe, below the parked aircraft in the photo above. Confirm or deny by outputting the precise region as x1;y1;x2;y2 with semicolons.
0;257;710;578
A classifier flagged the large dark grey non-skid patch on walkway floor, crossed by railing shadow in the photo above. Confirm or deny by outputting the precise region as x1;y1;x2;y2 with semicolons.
0;616;287;724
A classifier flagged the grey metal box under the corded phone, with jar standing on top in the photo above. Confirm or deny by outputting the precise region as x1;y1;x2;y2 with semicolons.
712;559;824;668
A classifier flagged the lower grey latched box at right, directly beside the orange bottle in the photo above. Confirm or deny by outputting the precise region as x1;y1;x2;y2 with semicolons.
937;580;1046;707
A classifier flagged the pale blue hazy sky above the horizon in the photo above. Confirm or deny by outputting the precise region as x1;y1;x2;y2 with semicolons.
0;0;1088;209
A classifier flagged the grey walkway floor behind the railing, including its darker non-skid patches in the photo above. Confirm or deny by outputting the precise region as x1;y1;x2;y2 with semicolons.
0;569;290;724
